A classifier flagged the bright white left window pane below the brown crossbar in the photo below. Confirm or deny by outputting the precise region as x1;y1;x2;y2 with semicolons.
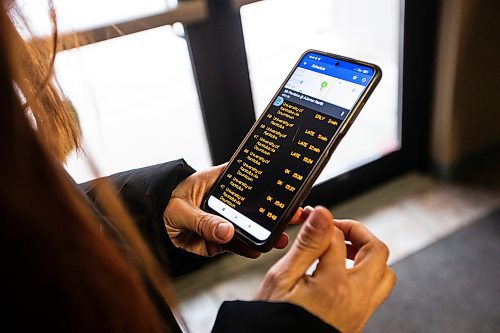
56;26;212;181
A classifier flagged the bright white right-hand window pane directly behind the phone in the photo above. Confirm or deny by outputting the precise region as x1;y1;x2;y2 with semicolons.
241;0;402;182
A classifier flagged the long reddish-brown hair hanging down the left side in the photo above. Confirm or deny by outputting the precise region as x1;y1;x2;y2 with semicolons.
0;1;178;332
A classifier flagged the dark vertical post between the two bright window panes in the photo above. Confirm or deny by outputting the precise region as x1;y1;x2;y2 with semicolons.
185;0;255;164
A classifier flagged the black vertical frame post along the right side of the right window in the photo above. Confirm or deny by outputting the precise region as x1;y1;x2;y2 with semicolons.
402;1;441;171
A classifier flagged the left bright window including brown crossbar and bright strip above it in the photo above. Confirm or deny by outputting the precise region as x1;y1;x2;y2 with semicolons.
18;0;212;182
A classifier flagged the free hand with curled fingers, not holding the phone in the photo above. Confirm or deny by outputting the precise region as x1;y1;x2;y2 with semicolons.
256;207;396;332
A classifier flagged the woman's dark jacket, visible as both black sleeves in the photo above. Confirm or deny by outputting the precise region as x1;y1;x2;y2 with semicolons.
80;160;337;333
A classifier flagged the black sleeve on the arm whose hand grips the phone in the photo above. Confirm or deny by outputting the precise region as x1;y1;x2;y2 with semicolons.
78;159;207;276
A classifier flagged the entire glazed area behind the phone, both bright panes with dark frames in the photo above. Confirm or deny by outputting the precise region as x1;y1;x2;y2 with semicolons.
22;0;439;204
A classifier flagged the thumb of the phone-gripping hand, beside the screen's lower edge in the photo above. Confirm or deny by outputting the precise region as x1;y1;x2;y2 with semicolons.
169;199;234;244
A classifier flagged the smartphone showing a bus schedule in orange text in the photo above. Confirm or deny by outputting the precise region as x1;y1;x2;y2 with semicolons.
203;50;382;252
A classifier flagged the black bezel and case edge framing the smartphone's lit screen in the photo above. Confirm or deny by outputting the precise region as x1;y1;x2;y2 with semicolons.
202;49;382;252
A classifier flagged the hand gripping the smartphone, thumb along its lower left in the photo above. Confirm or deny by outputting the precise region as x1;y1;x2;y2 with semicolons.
163;164;312;258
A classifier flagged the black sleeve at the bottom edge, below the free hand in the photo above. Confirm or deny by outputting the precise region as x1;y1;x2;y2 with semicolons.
212;301;339;333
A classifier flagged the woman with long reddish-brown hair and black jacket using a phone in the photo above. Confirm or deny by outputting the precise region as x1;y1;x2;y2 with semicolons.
0;2;395;332
